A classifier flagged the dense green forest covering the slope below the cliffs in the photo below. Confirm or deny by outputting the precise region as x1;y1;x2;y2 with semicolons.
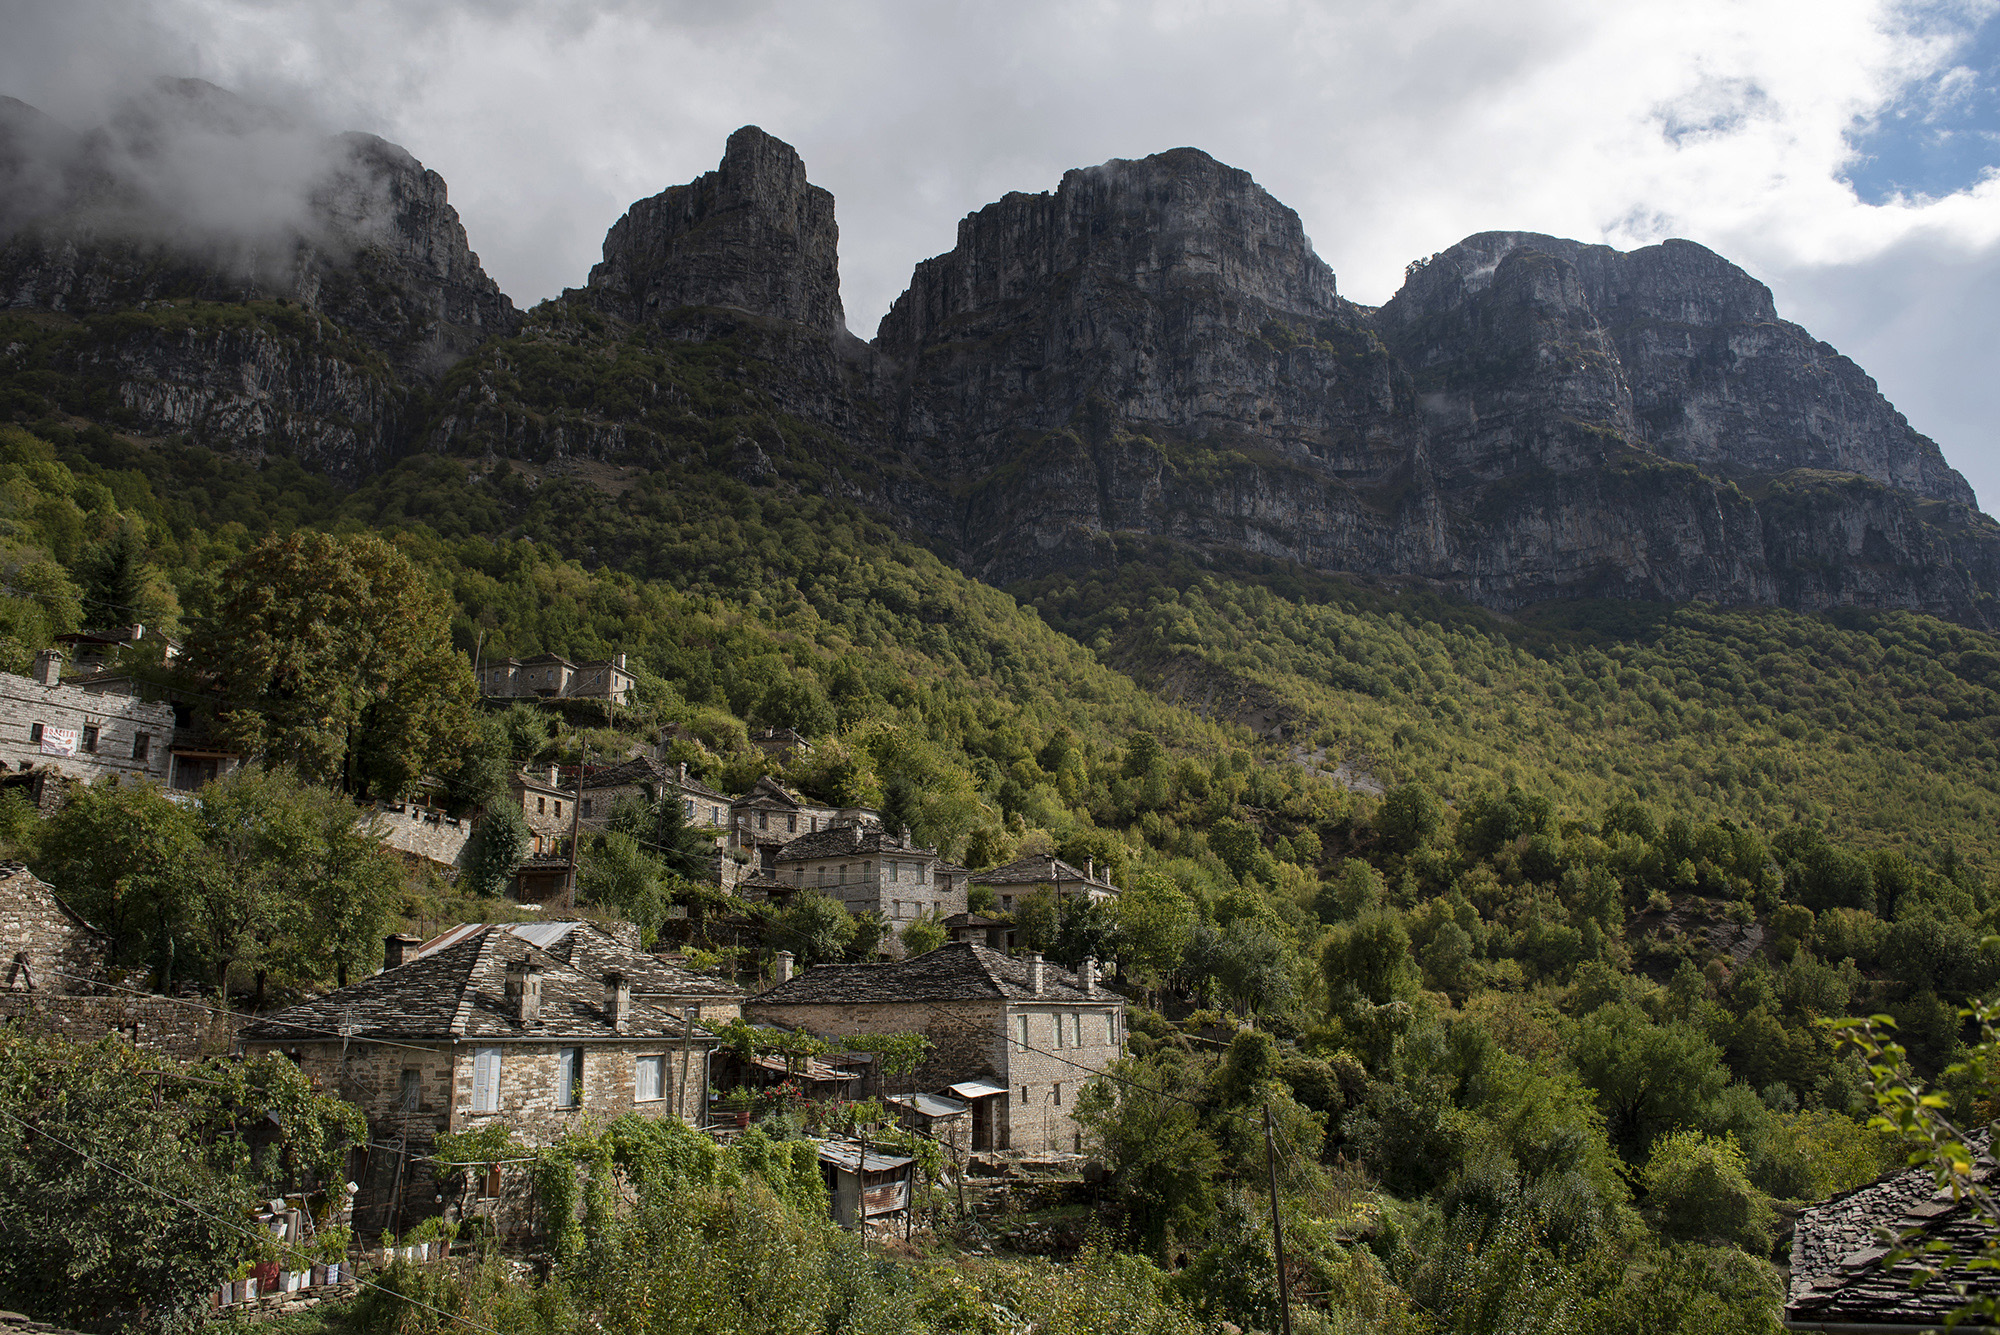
0;293;2000;1333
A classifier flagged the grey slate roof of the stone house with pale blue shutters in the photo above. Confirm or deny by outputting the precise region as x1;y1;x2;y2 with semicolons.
238;923;708;1041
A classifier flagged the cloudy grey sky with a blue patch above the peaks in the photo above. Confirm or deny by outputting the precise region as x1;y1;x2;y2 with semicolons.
11;0;2000;504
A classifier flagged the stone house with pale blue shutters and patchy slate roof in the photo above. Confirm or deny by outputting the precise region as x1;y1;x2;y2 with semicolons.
240;923;716;1233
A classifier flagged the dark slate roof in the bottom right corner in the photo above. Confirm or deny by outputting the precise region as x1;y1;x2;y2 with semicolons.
1784;1137;2000;1329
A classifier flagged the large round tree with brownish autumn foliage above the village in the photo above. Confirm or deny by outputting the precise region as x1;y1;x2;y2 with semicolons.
188;532;478;797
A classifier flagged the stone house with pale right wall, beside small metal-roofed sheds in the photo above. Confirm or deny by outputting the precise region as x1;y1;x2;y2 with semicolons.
744;941;1126;1151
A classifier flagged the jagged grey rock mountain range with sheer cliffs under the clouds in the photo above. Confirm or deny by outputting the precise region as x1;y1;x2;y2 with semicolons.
0;104;2000;626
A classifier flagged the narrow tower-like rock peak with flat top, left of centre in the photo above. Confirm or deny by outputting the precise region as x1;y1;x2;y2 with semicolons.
588;126;848;338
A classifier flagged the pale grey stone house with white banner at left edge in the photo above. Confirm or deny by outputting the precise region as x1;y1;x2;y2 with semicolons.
0;650;174;803
